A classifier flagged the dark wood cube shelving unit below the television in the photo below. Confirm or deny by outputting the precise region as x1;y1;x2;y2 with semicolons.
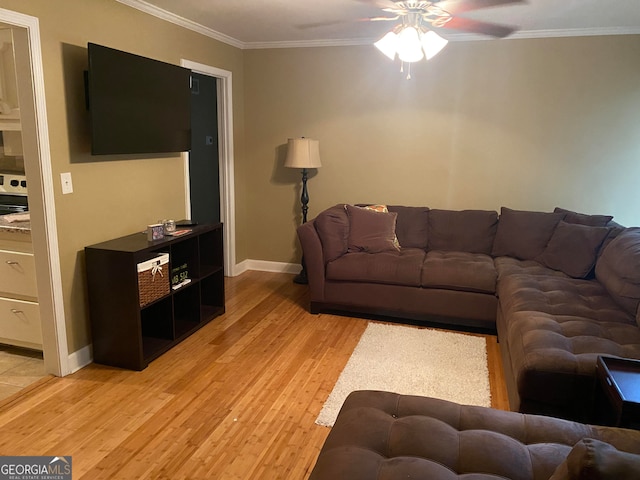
85;223;225;370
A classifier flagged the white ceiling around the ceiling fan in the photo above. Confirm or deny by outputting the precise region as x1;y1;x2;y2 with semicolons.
117;0;640;48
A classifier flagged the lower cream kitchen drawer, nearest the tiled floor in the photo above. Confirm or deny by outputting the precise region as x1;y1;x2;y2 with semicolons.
0;297;42;346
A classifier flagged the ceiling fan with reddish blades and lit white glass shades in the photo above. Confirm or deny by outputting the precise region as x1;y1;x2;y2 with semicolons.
360;0;526;78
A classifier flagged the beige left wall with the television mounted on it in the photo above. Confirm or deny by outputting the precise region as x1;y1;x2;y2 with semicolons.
0;0;244;352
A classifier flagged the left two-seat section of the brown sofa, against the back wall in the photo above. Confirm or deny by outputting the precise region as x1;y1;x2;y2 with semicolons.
298;205;498;330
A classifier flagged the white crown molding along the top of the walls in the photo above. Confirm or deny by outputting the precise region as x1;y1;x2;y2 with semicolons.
116;0;640;50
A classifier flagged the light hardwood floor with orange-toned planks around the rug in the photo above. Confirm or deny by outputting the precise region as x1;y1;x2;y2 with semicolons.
0;272;508;480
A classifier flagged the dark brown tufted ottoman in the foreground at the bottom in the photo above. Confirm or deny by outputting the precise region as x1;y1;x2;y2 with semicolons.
309;391;640;480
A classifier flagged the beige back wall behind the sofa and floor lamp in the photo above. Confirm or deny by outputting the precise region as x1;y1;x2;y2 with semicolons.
242;36;640;262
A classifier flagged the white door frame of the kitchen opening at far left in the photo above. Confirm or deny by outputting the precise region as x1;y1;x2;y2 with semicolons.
0;9;68;376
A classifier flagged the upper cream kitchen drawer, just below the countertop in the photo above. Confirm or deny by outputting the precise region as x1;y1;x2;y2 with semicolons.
0;250;38;298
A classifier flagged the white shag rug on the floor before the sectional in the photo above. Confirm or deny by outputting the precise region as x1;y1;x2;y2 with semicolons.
316;323;491;427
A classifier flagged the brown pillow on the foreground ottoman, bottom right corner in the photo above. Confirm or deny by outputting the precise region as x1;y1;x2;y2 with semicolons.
549;438;640;480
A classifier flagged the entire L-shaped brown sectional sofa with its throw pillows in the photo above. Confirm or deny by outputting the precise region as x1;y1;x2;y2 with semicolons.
298;205;640;422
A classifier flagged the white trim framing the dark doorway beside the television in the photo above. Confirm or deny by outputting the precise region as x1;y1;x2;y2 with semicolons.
180;60;236;277
